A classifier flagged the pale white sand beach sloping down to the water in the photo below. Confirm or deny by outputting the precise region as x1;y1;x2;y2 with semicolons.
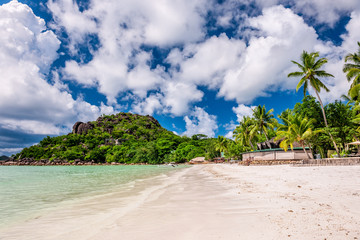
0;164;360;240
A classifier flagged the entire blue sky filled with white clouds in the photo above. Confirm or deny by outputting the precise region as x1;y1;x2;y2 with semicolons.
0;0;360;155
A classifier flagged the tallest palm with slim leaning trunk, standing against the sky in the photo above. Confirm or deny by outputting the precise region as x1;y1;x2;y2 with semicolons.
288;51;340;157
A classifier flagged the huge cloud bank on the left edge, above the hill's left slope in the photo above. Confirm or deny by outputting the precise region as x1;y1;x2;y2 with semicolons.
0;1;113;134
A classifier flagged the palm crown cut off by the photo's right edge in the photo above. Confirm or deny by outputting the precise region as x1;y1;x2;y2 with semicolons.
343;42;360;91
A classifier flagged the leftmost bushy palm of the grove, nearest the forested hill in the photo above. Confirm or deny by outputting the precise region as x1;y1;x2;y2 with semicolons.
234;116;255;150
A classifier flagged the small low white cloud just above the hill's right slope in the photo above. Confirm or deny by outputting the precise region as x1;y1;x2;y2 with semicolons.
183;107;218;137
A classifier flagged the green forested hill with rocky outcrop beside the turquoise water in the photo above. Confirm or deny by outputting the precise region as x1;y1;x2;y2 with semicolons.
13;113;219;164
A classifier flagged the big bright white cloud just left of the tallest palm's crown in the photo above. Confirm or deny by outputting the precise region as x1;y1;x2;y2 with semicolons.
219;6;321;103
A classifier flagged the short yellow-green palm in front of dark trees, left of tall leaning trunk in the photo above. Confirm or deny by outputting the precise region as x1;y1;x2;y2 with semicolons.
275;112;322;159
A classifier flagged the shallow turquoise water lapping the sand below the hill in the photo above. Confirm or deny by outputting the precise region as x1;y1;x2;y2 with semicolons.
0;166;178;226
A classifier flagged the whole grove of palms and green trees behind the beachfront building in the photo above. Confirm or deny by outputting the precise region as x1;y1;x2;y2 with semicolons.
234;45;360;158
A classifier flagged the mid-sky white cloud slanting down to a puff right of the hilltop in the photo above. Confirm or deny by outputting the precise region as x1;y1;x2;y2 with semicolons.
157;34;245;116
